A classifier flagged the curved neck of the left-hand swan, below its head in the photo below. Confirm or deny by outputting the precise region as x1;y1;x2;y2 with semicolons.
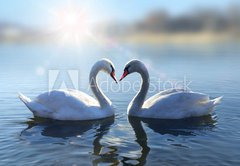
89;64;111;108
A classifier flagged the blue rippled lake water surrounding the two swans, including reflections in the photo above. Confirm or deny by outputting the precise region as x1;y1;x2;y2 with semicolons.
0;43;240;165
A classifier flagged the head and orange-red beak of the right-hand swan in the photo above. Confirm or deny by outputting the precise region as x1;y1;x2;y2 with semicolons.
120;59;147;81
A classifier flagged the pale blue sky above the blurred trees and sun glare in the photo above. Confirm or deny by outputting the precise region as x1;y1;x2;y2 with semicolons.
0;0;239;27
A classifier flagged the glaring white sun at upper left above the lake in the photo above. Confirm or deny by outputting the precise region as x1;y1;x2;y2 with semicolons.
49;5;94;44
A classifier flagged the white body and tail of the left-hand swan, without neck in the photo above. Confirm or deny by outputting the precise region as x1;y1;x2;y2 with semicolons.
19;90;103;120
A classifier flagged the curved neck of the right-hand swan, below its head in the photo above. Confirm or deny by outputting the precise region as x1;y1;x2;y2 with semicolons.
129;68;149;113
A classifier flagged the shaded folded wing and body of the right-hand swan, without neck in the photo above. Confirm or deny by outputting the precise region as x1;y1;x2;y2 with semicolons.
144;92;216;119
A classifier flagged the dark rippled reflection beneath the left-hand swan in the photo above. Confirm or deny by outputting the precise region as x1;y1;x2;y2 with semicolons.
20;117;119;165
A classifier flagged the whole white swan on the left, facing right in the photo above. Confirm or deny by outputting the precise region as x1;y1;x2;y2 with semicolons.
19;59;117;120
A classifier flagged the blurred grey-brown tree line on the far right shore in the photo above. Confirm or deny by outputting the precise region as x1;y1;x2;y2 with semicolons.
105;5;240;35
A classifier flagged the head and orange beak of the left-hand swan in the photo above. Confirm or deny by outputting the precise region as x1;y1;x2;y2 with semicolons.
96;58;117;83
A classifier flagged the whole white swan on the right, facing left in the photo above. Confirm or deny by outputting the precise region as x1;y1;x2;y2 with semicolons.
120;60;221;119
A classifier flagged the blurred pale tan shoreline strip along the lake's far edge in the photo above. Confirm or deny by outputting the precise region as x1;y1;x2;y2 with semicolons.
0;32;240;44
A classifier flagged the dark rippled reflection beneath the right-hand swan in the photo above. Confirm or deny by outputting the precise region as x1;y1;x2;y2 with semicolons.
125;115;216;165
